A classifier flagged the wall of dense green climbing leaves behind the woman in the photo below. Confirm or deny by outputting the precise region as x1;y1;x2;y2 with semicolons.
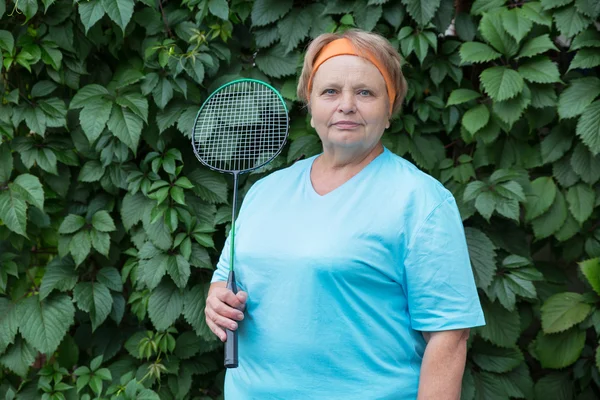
0;0;600;400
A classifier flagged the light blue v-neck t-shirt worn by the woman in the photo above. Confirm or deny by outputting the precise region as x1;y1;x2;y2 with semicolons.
213;149;485;400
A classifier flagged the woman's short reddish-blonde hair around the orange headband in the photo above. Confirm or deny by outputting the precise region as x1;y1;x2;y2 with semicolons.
297;29;407;115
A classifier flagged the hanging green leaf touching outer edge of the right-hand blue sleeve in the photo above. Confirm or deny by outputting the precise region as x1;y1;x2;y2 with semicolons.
465;228;496;289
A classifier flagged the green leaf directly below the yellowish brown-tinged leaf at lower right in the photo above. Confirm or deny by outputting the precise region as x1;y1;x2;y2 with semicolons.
535;329;585;369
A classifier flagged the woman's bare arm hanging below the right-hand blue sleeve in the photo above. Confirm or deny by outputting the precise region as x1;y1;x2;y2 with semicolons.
417;329;469;400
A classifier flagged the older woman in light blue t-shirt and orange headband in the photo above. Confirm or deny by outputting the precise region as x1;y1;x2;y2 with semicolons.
205;31;484;400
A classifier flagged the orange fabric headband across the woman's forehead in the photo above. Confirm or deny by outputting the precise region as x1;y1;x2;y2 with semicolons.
308;38;396;114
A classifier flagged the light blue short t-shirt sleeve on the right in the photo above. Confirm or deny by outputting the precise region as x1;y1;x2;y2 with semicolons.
404;195;485;332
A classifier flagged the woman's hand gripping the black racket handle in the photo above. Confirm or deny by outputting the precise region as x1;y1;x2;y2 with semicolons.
204;282;248;342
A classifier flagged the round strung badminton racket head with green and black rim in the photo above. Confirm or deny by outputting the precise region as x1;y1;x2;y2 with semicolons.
192;79;289;173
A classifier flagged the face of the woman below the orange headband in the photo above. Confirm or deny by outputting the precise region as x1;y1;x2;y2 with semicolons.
310;55;390;154
